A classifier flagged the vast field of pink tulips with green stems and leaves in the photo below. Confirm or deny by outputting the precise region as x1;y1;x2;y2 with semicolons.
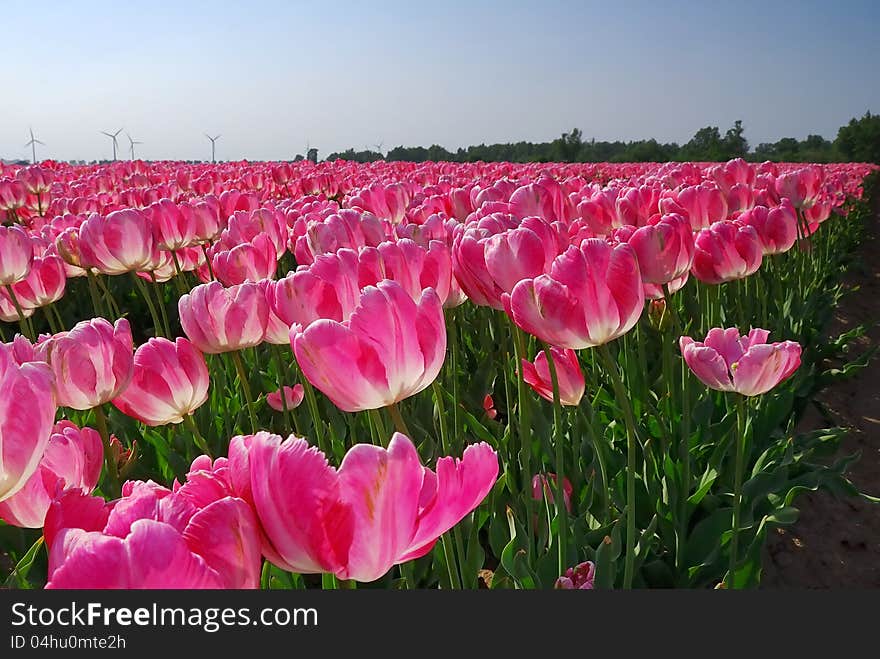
0;160;878;589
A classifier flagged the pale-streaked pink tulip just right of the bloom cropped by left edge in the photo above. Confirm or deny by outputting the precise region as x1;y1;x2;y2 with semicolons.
36;318;134;410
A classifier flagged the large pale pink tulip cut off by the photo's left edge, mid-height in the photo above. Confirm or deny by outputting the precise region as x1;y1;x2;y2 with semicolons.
0;346;55;501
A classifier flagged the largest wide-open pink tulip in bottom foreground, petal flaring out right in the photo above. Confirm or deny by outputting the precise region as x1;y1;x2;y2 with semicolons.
229;432;498;581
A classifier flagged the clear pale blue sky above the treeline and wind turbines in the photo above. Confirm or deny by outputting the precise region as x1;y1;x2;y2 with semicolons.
0;0;880;160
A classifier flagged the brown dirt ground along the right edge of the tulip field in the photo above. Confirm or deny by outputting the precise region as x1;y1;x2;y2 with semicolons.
761;204;880;588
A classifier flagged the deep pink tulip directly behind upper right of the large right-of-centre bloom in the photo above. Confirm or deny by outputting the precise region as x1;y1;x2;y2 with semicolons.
628;215;694;285
